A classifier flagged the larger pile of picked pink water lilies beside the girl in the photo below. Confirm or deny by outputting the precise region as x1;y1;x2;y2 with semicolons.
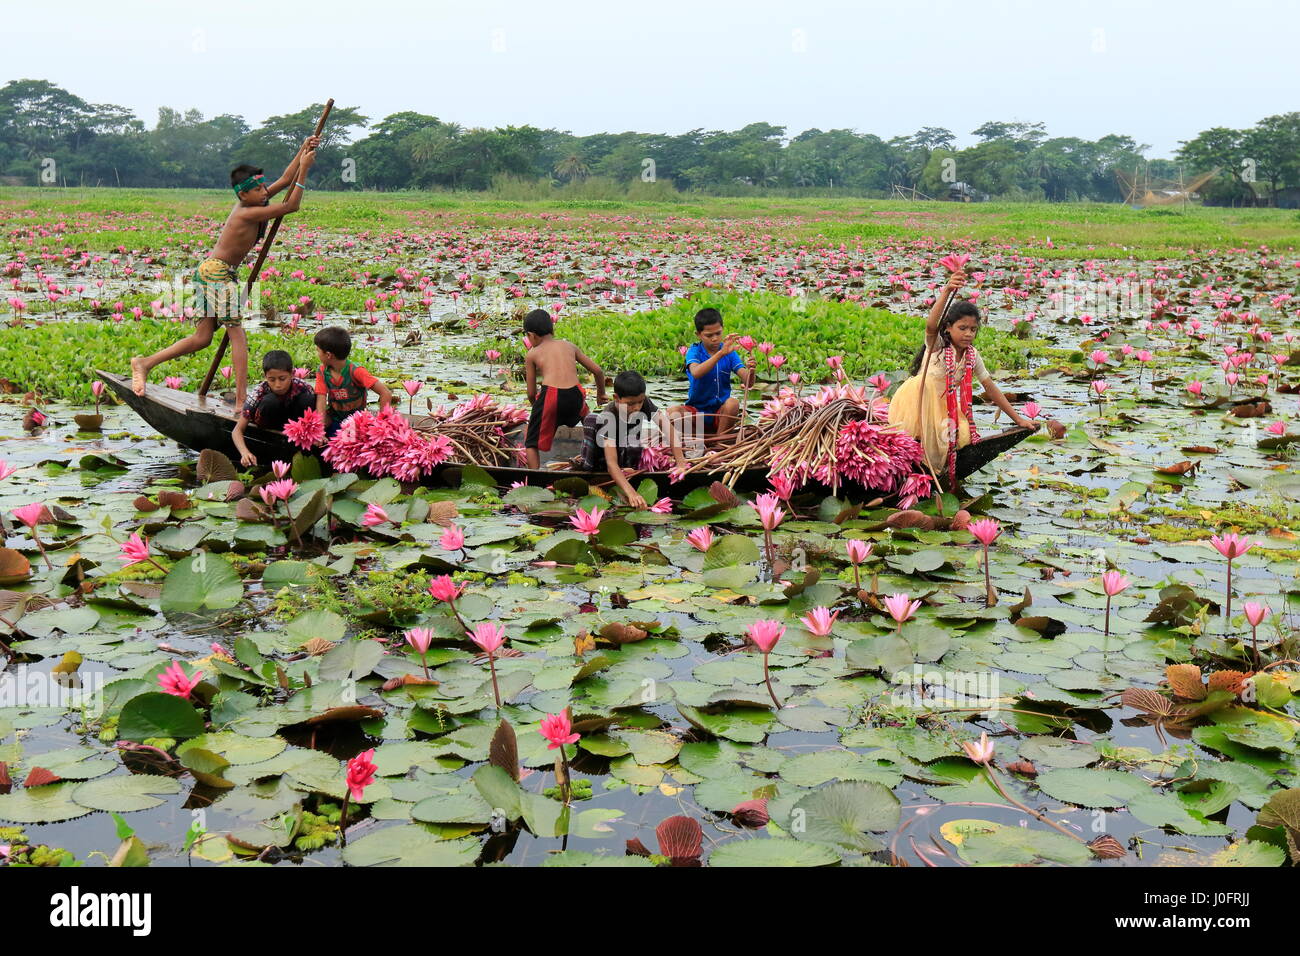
690;384;922;494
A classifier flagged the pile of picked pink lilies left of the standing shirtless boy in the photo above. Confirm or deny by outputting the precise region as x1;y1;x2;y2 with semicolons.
315;395;528;481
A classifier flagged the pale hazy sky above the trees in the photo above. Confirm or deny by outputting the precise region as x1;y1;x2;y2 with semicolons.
0;0;1300;159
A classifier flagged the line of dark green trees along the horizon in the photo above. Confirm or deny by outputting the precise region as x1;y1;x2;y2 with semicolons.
0;79;1300;204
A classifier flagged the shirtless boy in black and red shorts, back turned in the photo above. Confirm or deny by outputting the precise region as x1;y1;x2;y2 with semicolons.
524;308;605;471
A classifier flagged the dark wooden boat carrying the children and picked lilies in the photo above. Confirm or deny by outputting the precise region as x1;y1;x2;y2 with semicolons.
96;371;1032;498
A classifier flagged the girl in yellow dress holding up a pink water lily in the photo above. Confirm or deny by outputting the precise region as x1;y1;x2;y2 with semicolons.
889;272;1040;486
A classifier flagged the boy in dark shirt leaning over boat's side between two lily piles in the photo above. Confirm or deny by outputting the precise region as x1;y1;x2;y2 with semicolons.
582;372;688;509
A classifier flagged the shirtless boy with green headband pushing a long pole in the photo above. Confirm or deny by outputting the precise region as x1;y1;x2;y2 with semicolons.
131;137;320;408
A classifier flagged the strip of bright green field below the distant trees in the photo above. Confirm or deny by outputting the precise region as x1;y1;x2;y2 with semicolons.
0;187;1300;258
